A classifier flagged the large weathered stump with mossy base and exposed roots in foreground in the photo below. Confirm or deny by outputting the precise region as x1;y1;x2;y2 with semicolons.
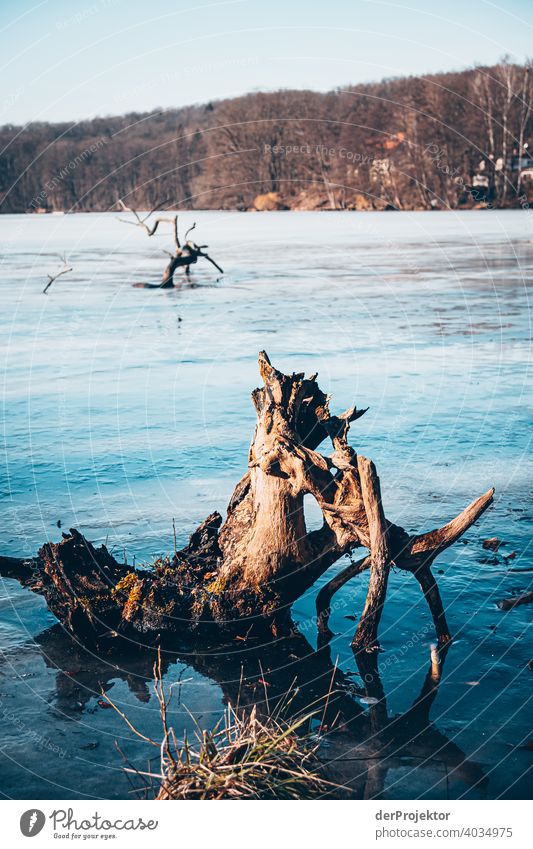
0;352;494;650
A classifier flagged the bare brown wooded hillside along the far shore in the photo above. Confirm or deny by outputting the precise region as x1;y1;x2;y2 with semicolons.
0;59;533;213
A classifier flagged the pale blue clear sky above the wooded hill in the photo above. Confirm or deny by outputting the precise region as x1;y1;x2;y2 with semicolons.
0;0;533;124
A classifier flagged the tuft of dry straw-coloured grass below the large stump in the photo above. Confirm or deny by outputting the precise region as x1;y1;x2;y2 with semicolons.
106;659;333;800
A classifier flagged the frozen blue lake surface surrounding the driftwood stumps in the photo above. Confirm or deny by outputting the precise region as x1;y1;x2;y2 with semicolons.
0;211;533;798
